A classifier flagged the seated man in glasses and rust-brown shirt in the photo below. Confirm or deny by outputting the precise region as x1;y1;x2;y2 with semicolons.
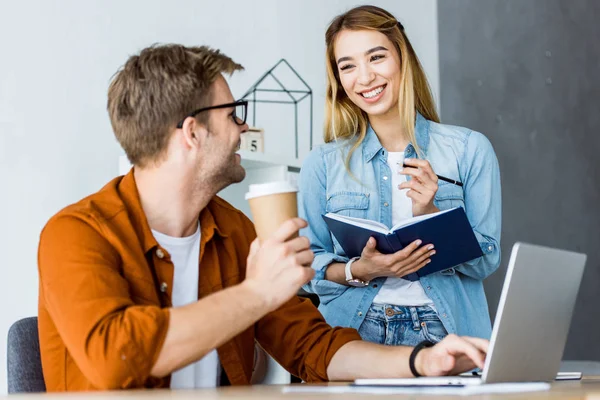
38;45;487;391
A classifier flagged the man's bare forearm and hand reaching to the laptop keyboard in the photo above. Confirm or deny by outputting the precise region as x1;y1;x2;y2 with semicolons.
327;335;488;381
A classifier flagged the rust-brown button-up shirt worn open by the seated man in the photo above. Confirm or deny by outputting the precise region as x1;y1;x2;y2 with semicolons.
38;170;360;391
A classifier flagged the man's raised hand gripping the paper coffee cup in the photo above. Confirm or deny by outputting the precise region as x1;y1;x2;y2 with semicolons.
243;218;314;311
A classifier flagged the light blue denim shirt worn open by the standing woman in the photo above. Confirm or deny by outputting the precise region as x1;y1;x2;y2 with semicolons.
299;114;501;338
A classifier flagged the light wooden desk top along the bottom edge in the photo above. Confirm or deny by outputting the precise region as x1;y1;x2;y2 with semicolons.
1;380;600;400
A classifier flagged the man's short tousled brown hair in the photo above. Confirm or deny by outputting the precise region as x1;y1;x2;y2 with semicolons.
108;44;243;167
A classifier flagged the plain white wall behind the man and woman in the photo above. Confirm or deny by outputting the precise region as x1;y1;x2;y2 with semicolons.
0;0;439;393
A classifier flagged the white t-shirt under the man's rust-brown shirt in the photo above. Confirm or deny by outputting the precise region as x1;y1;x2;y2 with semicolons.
152;225;221;389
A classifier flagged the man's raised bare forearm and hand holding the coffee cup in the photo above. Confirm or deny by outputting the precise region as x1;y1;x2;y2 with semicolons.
152;218;314;376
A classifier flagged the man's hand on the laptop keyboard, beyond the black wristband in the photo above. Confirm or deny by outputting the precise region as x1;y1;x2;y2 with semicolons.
415;335;489;376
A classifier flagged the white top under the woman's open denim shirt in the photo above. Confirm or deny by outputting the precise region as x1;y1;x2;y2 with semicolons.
373;152;433;306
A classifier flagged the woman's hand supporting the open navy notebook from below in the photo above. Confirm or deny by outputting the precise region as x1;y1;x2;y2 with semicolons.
352;237;435;281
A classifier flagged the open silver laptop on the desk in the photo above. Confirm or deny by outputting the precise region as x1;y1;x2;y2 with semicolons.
354;243;587;386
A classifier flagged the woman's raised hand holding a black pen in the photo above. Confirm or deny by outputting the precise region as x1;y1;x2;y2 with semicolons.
398;158;439;217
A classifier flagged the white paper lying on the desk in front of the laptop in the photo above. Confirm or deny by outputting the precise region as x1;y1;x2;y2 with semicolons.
283;382;550;396
